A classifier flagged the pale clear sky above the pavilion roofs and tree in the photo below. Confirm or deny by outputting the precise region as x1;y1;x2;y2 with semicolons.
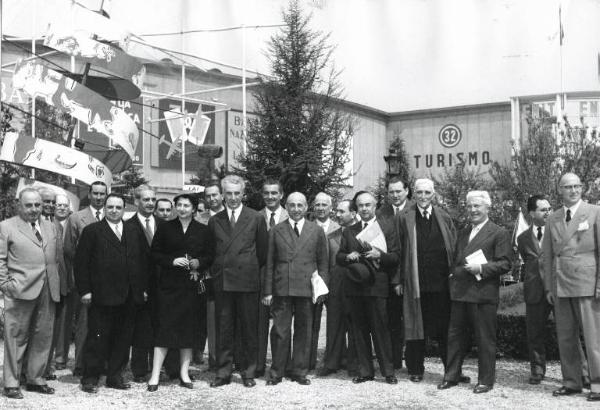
2;0;600;112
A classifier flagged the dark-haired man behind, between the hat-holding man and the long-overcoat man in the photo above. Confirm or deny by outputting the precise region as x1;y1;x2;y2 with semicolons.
377;177;414;369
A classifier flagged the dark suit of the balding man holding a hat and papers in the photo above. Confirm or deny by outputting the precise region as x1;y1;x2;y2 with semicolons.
337;220;400;377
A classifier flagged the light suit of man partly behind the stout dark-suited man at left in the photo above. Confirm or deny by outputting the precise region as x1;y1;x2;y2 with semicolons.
65;206;102;370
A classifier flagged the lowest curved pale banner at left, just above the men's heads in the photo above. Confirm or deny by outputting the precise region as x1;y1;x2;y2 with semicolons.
0;132;112;186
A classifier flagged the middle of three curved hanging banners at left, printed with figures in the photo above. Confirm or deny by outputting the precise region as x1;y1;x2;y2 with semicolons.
13;61;138;159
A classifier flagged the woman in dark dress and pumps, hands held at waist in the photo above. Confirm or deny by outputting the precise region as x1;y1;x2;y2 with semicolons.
148;194;213;391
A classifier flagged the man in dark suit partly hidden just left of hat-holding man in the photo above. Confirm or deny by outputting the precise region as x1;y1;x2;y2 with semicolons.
319;199;356;377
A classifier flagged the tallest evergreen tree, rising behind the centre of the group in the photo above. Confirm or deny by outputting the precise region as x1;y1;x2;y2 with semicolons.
235;0;353;208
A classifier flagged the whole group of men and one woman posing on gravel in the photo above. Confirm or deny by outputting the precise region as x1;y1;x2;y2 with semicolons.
0;174;600;401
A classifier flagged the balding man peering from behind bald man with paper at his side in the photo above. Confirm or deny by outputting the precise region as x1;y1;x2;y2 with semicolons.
308;192;340;370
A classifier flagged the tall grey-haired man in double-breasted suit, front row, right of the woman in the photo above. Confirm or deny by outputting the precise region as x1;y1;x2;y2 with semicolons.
208;175;268;387
